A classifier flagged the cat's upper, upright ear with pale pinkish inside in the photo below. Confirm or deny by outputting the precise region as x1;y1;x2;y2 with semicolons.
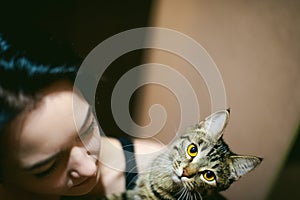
200;109;229;140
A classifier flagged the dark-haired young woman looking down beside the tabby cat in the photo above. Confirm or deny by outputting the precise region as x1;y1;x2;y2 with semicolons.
0;33;162;200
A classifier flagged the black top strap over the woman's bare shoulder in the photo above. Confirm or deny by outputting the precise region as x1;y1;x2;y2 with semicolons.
118;138;138;190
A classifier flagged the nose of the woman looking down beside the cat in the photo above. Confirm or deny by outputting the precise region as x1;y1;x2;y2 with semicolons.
69;146;98;178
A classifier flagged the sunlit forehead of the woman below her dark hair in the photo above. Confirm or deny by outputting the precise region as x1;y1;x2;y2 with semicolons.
5;82;89;164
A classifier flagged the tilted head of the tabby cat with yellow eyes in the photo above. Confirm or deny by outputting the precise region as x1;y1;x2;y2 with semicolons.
170;110;262;197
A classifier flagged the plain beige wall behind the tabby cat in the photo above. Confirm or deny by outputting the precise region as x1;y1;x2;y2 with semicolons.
138;0;300;200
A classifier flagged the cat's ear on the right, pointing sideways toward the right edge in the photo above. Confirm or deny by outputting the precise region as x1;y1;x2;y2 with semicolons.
230;156;262;181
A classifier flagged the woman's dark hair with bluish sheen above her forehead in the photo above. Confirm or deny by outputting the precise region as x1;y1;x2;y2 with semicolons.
0;33;80;130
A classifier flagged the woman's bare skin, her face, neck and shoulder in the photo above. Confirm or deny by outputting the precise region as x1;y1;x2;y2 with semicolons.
0;82;163;200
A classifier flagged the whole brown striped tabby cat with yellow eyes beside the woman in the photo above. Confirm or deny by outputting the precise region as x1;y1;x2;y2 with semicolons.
106;110;262;200
